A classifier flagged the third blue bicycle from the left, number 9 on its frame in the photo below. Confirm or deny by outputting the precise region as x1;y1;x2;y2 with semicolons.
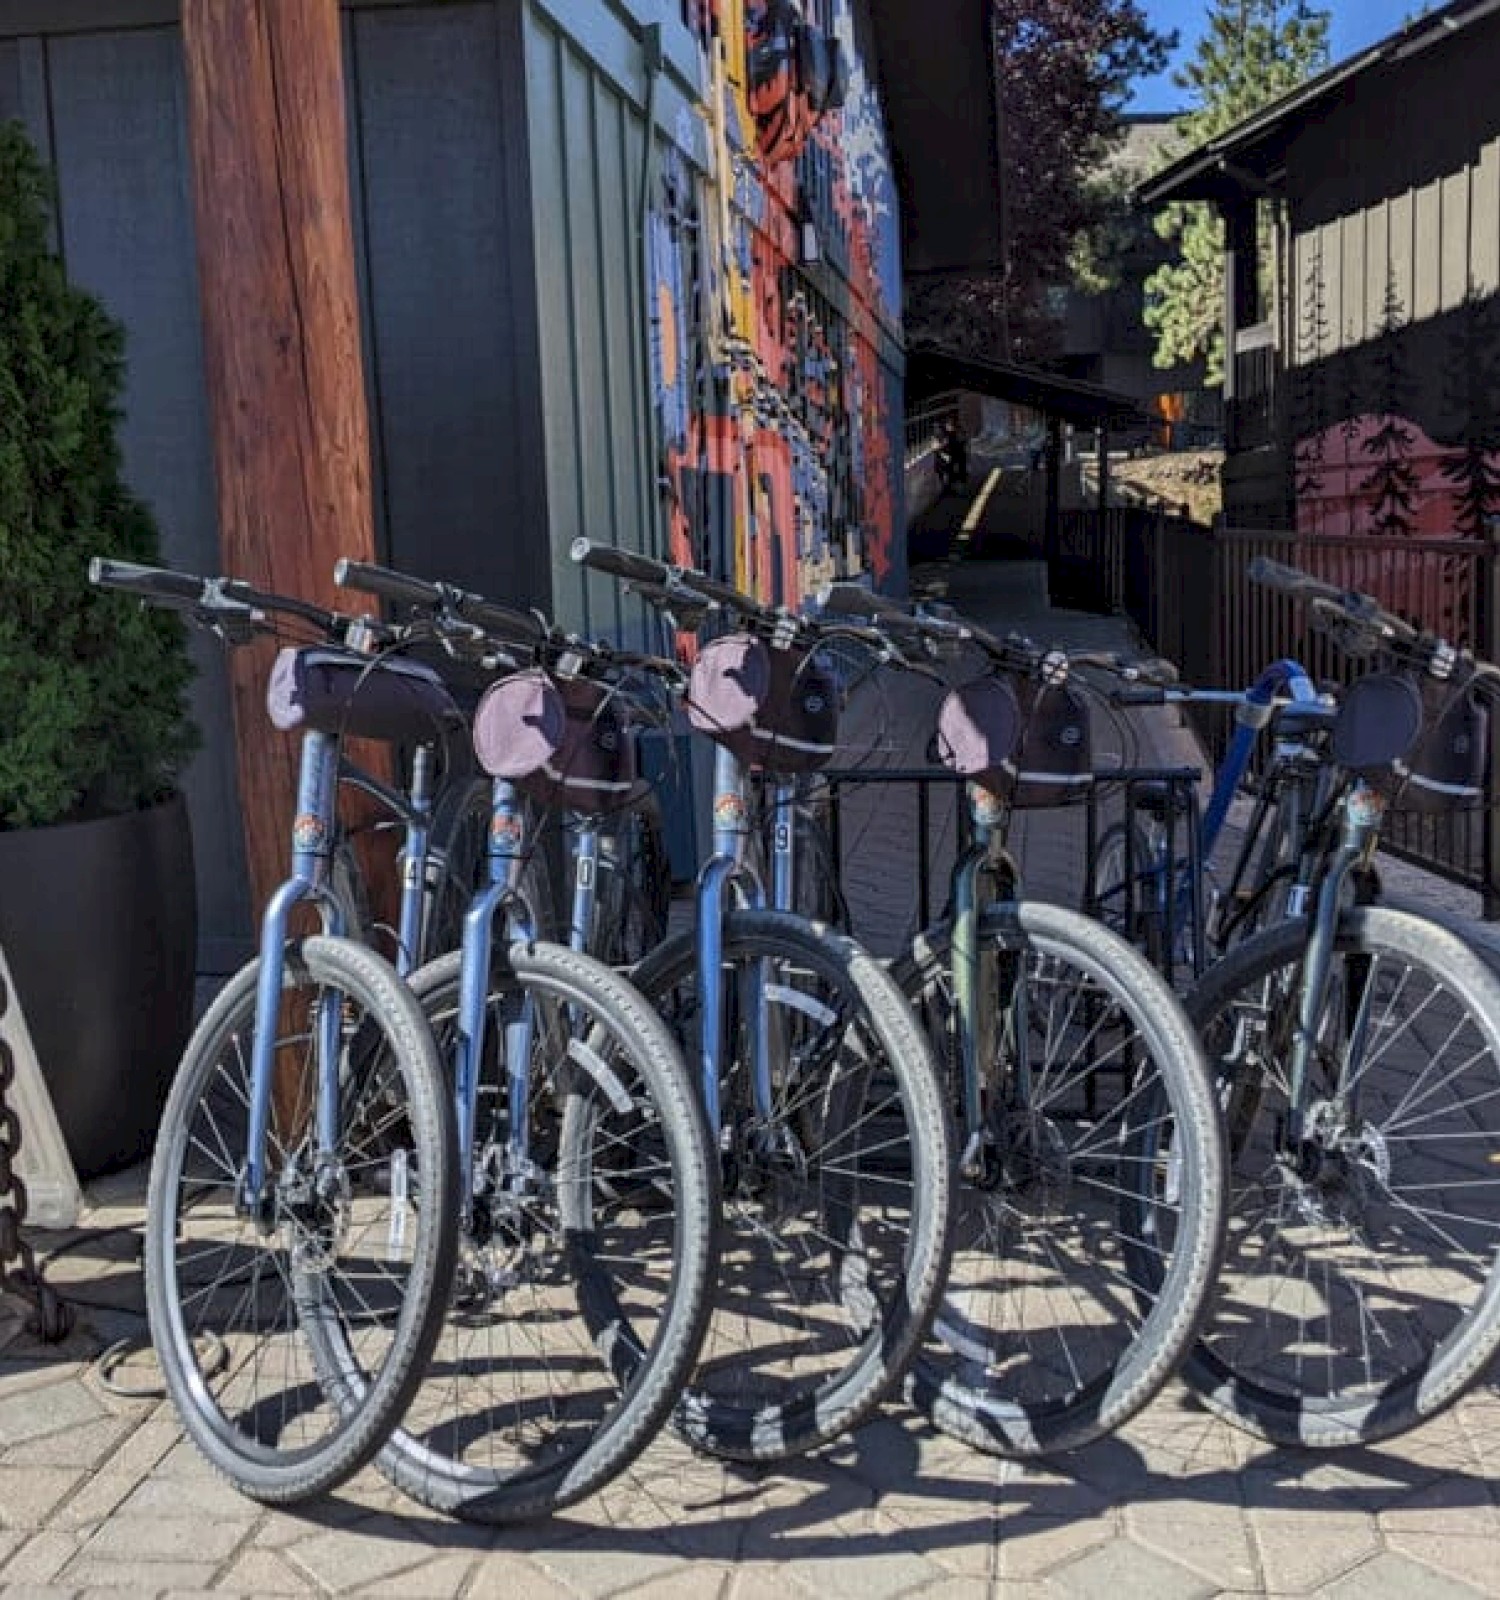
572;539;951;1461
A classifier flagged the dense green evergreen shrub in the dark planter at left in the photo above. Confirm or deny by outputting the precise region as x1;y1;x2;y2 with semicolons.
0;123;195;827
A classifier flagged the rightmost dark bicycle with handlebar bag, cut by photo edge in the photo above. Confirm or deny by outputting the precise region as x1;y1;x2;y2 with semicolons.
1183;558;1500;1448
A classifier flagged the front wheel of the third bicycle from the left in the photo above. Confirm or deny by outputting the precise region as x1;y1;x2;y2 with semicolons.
635;910;951;1461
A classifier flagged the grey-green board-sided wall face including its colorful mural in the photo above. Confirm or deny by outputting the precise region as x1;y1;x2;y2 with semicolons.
526;0;904;629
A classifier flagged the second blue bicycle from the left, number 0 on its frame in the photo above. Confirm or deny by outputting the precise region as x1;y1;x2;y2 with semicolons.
316;562;718;1523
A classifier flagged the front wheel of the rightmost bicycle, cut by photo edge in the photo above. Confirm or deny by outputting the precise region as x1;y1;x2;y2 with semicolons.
1185;909;1500;1446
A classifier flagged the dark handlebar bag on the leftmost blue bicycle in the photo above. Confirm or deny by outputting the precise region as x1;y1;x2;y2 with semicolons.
265;645;459;744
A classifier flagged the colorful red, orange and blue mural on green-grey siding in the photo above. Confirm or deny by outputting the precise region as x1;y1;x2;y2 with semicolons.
649;0;902;605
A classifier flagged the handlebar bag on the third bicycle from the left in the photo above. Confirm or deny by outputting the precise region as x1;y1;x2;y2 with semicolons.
688;634;838;773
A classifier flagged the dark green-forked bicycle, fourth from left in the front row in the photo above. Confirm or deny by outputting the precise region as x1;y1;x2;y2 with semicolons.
805;586;1225;1456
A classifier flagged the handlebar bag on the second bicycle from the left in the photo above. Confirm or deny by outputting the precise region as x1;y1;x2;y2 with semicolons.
473;667;646;816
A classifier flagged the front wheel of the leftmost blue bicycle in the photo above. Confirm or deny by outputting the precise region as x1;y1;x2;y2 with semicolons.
146;938;457;1502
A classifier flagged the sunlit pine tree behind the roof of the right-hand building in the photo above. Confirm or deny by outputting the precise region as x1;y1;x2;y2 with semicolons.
1145;0;1329;384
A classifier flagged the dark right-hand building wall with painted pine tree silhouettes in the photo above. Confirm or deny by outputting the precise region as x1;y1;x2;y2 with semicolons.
1281;18;1500;534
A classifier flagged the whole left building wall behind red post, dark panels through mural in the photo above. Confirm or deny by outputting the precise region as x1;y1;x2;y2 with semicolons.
0;0;904;970
